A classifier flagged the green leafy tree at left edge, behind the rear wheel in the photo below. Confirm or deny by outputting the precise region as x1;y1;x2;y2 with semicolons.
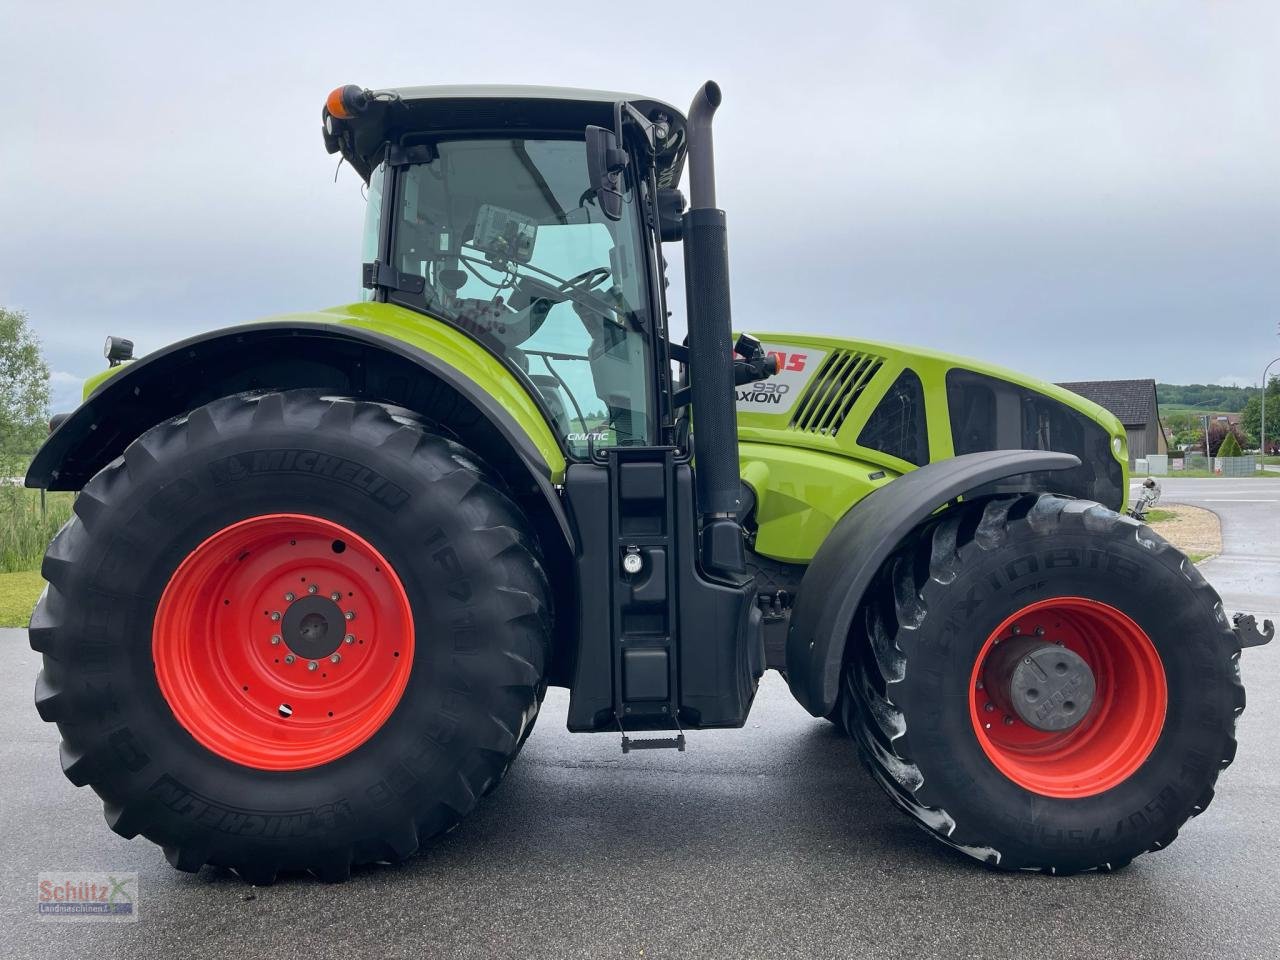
0;307;49;460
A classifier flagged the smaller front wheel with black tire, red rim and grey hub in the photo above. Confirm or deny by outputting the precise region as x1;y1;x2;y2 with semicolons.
841;495;1244;873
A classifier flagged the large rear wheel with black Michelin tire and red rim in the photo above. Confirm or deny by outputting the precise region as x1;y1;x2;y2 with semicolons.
31;390;550;882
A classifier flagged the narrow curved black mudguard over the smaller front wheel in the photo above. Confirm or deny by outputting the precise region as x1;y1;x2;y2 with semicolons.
786;451;1080;717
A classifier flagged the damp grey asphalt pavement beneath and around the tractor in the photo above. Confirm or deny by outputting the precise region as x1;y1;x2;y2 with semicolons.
0;479;1280;960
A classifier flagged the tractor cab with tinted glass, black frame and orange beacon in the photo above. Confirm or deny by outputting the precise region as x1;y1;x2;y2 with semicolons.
325;86;685;457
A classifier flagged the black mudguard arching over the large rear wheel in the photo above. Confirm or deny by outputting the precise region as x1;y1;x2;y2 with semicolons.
26;321;572;544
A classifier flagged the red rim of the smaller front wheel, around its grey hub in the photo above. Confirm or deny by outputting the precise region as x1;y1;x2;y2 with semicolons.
969;596;1169;797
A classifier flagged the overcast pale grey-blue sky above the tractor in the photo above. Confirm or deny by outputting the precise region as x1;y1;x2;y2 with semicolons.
0;0;1280;407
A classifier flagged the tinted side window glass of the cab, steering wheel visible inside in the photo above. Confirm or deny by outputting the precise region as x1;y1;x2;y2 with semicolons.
373;140;652;456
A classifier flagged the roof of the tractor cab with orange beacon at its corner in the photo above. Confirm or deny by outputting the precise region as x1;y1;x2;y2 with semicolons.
324;83;686;187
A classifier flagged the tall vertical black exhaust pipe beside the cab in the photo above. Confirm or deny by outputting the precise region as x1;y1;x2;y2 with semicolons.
684;82;746;573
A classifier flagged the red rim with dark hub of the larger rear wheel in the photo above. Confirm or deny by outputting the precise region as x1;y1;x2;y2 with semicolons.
151;513;413;771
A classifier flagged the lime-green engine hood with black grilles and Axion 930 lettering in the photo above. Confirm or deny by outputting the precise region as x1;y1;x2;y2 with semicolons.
737;333;1128;563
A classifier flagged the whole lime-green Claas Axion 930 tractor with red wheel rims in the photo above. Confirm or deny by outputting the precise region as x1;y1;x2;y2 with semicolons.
27;83;1262;882
